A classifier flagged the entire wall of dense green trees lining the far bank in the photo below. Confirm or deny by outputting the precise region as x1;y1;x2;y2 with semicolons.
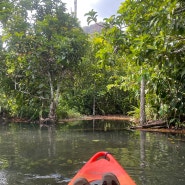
0;0;185;126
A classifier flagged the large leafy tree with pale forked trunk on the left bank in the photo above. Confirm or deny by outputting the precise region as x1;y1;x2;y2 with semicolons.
0;0;87;120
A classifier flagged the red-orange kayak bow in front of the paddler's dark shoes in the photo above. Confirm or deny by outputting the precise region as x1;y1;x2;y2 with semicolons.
68;152;136;185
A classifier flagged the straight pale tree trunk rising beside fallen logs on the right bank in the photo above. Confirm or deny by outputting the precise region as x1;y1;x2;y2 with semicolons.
140;76;146;126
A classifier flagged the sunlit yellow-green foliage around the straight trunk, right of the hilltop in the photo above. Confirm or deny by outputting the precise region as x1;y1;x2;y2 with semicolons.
84;0;185;125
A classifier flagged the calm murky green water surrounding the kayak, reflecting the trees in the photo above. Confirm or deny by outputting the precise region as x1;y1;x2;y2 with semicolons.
0;121;185;185
